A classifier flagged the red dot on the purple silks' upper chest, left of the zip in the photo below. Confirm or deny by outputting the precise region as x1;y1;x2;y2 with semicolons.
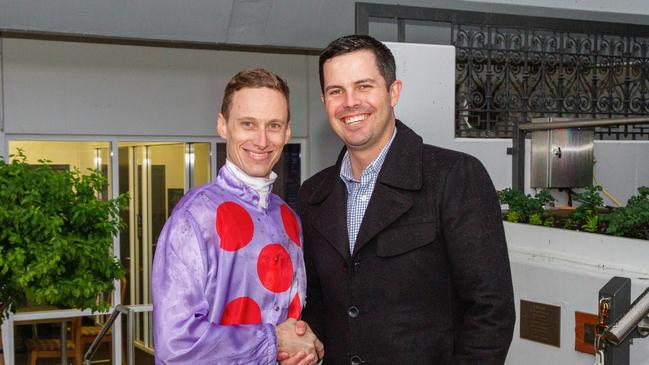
216;202;255;251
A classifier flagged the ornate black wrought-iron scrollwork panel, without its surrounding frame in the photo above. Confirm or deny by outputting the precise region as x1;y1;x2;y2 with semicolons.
452;24;649;139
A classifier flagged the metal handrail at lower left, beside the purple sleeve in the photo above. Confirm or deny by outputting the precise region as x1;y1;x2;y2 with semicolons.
83;304;153;365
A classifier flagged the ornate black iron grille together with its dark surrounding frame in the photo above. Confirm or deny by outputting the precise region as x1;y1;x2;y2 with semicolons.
356;3;649;140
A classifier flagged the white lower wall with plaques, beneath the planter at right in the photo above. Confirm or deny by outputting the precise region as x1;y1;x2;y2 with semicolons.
505;223;649;365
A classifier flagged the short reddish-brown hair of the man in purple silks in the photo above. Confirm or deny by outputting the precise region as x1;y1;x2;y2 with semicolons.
221;68;291;120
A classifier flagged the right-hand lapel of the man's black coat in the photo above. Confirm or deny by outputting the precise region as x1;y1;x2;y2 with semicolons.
354;120;423;254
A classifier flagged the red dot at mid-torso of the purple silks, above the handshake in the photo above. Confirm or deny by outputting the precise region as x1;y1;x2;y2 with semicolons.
257;243;293;293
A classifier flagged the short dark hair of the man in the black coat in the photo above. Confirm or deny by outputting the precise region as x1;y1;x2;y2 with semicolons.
319;34;397;92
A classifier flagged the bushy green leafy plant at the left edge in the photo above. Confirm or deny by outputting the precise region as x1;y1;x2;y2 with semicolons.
0;151;128;323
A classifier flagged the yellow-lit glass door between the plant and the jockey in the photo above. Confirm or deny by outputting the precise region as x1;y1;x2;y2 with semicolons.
119;142;211;352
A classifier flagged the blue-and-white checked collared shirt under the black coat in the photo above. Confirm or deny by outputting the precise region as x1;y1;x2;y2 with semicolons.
340;128;397;255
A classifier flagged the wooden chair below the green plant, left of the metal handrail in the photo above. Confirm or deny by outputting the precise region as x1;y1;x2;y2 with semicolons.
25;318;83;365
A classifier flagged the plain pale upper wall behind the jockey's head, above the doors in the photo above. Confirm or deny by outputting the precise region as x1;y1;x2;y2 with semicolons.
3;39;308;137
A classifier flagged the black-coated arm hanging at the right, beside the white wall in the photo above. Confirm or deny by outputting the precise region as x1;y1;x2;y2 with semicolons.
440;156;516;364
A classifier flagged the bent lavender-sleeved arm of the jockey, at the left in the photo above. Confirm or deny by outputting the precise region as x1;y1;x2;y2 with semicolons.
152;211;306;365
